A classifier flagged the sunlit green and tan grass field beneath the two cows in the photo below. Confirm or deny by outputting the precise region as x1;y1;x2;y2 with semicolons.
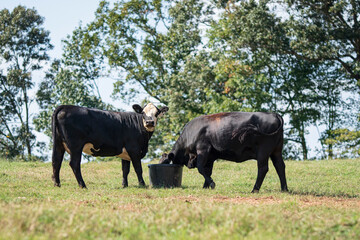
0;159;360;239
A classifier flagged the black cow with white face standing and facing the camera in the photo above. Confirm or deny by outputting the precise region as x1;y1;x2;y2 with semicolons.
52;103;168;188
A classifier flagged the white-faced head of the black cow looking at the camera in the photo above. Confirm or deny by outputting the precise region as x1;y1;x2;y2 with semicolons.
132;103;169;132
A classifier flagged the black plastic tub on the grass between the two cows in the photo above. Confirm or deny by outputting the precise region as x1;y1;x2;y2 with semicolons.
148;164;183;188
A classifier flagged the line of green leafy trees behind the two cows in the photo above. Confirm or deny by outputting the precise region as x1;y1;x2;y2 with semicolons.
0;0;360;159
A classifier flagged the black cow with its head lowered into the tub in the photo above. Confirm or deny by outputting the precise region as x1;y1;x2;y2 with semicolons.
160;112;288;192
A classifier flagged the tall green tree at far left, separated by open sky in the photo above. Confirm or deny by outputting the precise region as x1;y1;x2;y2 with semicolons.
0;6;52;159
